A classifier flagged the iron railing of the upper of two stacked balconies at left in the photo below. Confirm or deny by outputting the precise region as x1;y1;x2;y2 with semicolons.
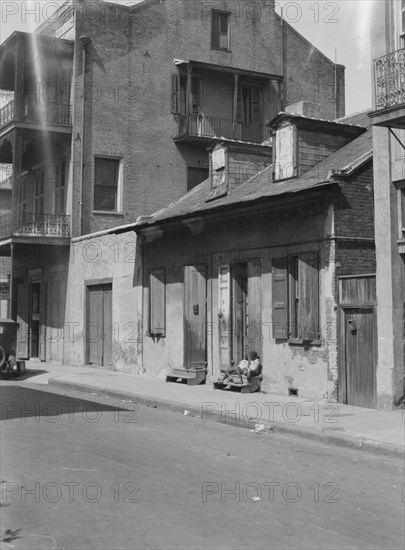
0;100;72;132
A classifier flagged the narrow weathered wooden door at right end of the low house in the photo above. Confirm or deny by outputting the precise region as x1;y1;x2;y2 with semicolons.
342;308;376;408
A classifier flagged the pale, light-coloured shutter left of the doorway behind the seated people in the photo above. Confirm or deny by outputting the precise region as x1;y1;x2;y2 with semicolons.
218;265;232;370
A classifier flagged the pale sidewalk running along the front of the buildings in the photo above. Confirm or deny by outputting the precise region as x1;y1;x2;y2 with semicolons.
17;361;405;462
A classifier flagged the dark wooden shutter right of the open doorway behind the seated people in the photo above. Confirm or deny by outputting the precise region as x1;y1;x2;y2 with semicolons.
248;259;262;357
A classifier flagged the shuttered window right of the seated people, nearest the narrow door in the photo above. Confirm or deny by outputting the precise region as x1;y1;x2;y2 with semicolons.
273;252;320;341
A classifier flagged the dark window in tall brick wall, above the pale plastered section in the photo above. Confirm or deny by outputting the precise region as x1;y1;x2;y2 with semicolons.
94;157;120;212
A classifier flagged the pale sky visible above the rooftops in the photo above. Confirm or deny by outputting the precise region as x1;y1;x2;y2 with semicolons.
0;0;373;114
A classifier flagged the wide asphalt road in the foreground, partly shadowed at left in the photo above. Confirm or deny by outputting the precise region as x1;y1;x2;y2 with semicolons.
0;382;405;550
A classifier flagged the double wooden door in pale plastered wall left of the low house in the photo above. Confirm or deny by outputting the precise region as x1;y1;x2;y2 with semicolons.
86;284;112;367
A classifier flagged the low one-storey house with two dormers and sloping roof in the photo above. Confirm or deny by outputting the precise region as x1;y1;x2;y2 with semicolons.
134;109;377;407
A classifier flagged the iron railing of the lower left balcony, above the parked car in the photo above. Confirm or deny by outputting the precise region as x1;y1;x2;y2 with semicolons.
0;212;70;239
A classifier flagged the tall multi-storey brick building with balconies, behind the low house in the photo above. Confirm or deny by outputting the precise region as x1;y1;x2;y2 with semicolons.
0;0;345;372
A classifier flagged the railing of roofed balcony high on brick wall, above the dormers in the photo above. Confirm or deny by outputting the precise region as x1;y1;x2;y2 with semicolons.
179;115;269;143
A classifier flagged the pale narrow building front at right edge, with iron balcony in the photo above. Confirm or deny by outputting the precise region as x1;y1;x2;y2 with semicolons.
370;0;405;407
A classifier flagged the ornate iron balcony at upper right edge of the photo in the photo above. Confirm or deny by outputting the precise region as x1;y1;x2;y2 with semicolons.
370;49;405;128
